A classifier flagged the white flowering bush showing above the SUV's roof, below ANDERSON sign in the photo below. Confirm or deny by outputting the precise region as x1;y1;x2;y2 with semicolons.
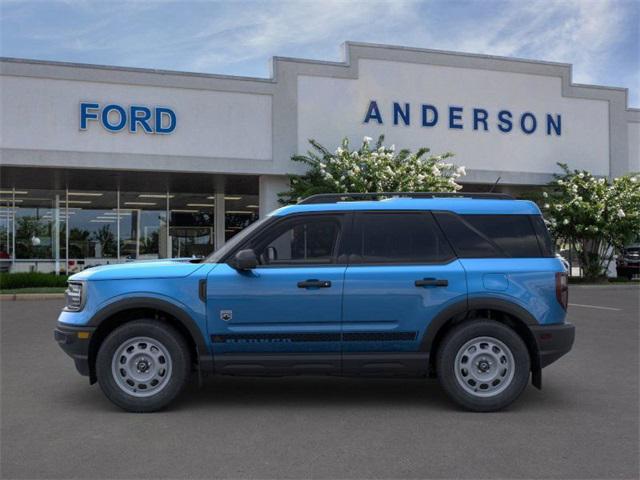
280;135;466;204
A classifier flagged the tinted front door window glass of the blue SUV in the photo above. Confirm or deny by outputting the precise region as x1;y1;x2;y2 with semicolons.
254;217;340;265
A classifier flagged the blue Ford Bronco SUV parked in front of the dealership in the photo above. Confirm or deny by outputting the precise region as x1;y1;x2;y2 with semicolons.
55;193;574;412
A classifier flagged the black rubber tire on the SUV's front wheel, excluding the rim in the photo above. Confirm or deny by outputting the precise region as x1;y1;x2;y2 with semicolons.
96;319;191;413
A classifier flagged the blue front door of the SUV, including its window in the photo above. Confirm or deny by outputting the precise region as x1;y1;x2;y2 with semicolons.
207;214;346;374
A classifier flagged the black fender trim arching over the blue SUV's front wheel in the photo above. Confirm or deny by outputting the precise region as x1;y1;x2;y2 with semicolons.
87;297;213;374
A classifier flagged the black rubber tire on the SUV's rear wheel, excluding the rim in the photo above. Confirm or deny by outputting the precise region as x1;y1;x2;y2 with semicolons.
436;319;531;412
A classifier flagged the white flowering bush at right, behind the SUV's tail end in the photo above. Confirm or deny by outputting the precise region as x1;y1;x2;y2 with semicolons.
542;163;640;279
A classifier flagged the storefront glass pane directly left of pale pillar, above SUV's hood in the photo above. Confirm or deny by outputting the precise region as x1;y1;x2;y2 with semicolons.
169;193;215;257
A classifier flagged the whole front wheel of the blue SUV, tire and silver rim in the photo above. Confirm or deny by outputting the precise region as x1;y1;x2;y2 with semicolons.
96;319;191;412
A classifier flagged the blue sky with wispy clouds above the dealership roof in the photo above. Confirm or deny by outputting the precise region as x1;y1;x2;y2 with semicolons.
0;0;640;107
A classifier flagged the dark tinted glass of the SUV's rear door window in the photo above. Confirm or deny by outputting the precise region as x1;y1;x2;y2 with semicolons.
351;212;454;264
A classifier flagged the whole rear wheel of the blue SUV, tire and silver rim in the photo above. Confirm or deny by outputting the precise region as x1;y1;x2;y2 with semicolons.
436;320;530;412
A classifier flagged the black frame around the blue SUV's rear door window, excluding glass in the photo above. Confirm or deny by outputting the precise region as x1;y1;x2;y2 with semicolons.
346;210;458;267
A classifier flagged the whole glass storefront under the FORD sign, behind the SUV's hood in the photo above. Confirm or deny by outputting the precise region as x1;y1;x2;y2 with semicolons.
0;183;259;273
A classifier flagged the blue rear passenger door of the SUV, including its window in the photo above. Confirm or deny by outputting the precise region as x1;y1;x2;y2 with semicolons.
342;212;467;374
